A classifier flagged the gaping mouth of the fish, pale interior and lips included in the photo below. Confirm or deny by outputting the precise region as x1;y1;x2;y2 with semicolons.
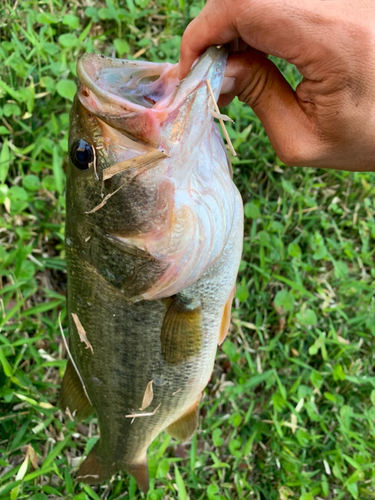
77;47;226;114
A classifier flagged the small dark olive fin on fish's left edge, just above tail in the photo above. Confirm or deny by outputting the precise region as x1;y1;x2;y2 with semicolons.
58;359;94;420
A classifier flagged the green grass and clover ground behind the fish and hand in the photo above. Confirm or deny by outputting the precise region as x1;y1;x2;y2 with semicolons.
0;0;375;500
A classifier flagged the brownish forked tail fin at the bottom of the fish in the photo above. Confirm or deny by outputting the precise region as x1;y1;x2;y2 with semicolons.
76;442;149;493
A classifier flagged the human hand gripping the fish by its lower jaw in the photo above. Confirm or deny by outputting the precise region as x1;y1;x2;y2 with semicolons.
180;0;375;171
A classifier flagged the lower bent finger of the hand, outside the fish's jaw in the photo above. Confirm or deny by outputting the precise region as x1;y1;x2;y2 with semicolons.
225;49;323;166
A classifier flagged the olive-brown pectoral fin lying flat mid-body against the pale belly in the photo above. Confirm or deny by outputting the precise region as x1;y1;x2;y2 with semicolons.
160;295;202;365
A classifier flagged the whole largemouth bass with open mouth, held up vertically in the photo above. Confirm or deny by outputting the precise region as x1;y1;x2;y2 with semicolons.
59;47;243;492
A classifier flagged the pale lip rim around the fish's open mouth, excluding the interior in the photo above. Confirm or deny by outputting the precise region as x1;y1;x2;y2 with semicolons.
77;47;228;115
